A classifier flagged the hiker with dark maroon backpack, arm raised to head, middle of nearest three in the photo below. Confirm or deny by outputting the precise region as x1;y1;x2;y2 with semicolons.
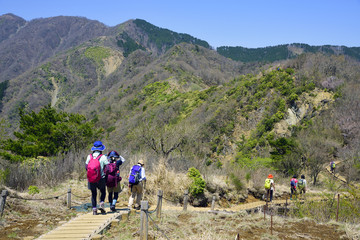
105;151;125;212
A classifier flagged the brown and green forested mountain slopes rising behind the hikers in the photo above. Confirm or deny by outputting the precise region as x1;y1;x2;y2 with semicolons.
0;15;360;186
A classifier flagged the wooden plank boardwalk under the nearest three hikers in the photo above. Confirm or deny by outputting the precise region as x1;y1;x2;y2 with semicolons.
38;211;127;240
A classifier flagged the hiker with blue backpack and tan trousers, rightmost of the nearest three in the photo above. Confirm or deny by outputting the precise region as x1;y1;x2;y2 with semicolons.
128;160;146;210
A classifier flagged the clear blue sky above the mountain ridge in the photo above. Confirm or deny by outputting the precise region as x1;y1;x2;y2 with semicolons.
0;0;360;48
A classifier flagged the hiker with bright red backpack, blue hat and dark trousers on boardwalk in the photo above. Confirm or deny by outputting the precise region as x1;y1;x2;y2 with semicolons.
86;141;109;215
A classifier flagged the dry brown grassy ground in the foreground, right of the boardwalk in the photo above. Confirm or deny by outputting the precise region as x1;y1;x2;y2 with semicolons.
104;211;358;240
